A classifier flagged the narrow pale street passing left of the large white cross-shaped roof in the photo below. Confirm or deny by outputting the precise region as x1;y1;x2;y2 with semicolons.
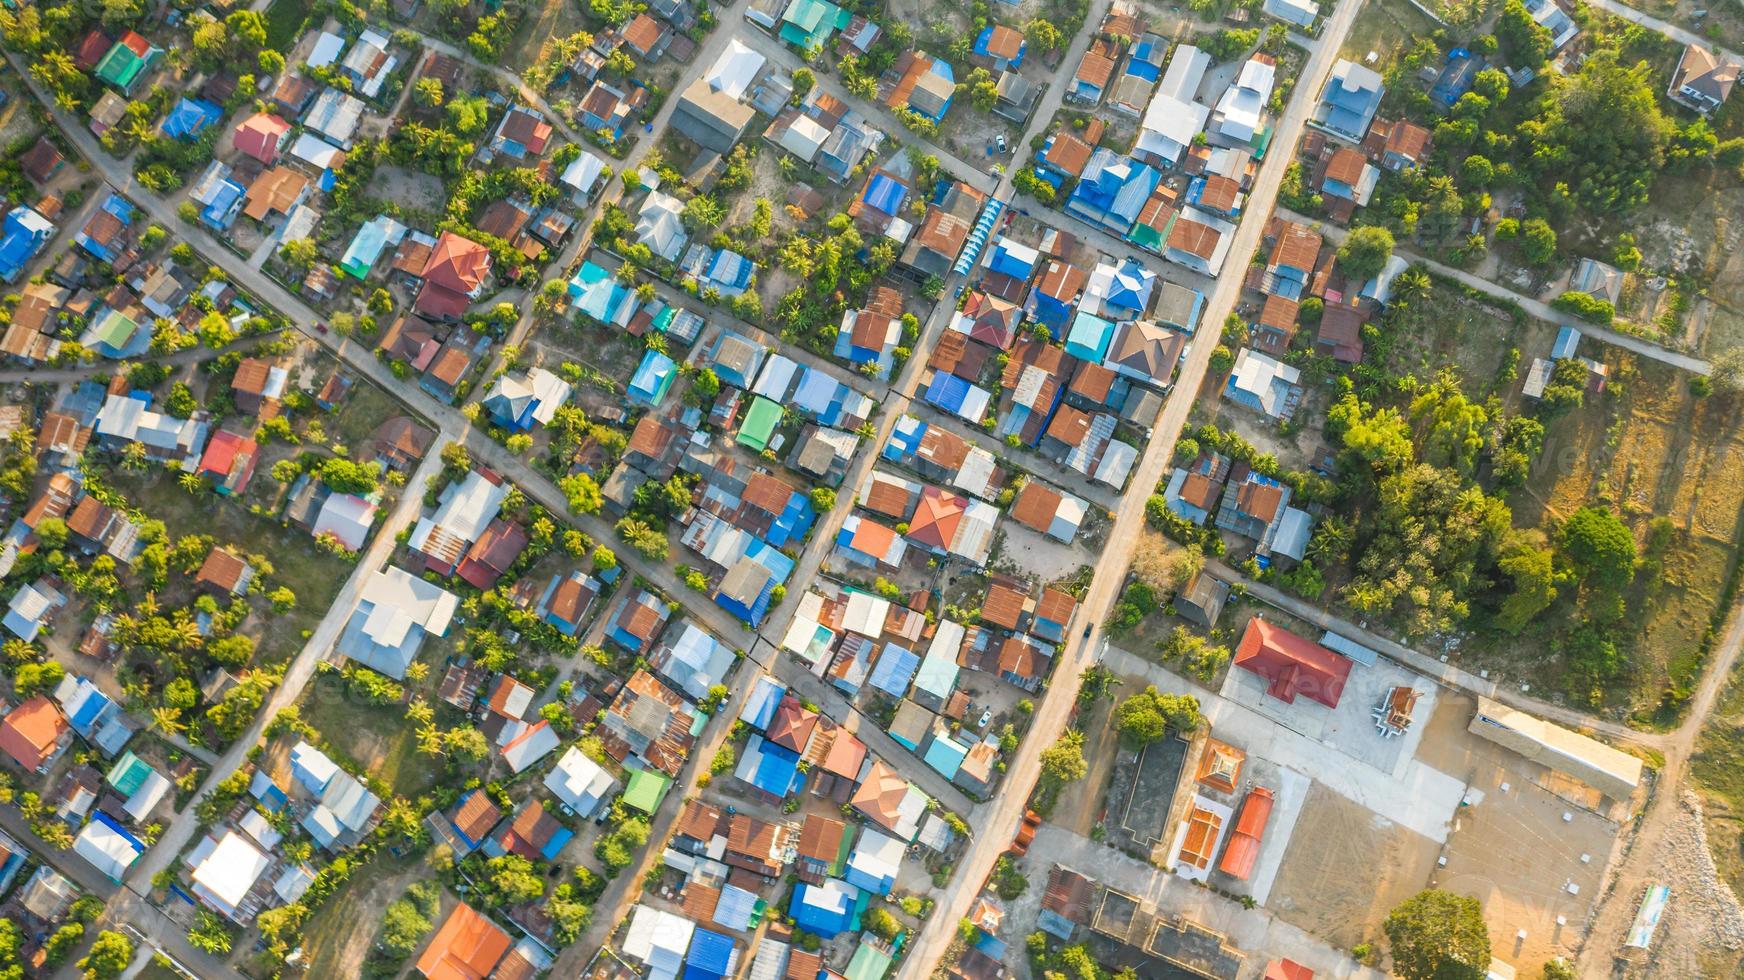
127;439;441;888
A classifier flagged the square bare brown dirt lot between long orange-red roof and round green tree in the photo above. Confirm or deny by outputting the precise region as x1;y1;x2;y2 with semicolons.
1266;770;1439;949
